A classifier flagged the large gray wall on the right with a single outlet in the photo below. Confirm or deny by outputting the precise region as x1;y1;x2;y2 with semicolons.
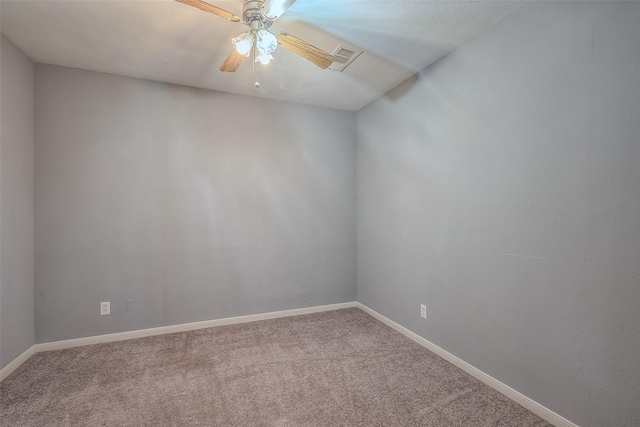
357;2;640;426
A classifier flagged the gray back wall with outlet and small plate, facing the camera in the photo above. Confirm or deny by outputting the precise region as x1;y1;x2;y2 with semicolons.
35;64;356;342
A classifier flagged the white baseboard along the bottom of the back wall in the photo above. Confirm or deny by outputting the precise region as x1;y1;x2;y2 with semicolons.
35;301;356;353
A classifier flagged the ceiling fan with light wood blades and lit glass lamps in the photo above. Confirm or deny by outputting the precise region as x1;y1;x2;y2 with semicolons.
176;0;334;72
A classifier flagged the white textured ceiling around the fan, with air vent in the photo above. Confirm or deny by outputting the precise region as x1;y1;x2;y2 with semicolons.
0;0;522;110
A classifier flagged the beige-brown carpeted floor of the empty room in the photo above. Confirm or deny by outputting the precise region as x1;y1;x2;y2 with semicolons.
0;308;549;427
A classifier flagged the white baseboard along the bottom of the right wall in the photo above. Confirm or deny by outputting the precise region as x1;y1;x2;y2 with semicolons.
356;303;578;427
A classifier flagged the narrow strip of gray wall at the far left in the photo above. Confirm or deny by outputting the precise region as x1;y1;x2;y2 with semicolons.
0;35;34;368
